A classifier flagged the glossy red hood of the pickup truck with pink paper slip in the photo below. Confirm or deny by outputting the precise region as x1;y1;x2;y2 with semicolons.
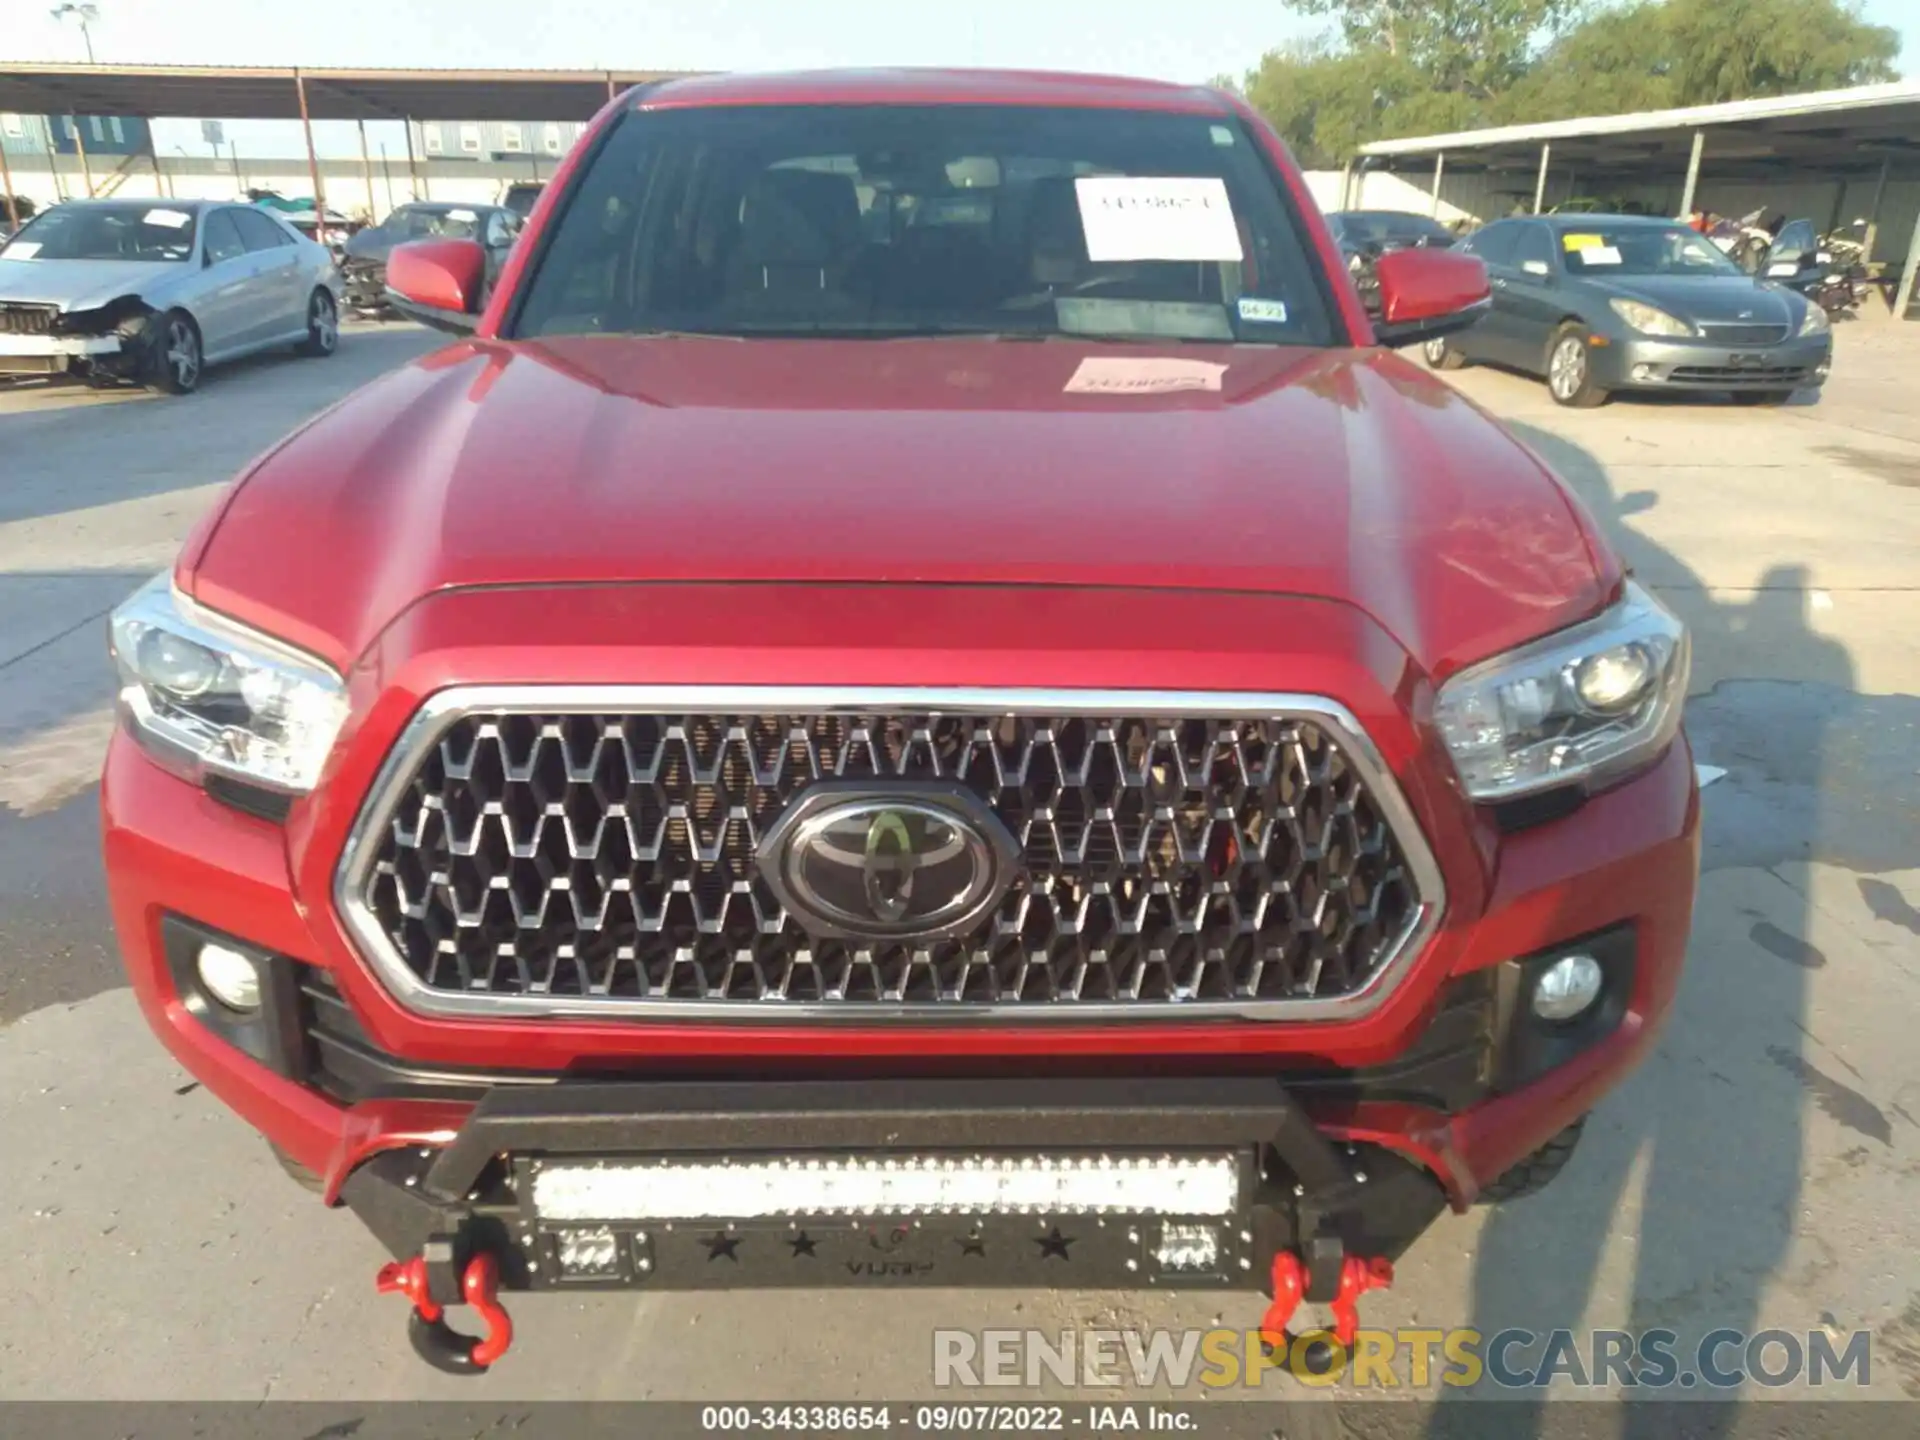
179;336;1619;674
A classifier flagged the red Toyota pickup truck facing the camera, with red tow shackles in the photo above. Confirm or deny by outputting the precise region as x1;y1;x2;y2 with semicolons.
104;71;1699;1371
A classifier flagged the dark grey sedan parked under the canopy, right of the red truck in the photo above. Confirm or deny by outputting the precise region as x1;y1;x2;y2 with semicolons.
1427;215;1834;407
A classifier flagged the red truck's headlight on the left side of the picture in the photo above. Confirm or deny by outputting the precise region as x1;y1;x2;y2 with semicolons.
109;574;348;791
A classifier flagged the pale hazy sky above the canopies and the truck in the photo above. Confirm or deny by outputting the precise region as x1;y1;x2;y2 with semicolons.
0;0;1920;156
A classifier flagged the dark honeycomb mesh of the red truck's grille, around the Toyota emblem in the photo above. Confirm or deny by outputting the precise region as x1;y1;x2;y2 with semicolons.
359;712;1421;1014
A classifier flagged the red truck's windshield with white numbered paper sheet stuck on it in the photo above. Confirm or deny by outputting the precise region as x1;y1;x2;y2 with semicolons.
511;106;1334;346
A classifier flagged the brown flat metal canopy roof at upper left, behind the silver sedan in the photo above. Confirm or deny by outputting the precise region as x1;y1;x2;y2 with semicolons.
0;61;698;121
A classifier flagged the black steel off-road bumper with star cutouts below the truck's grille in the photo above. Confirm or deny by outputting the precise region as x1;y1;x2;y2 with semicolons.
340;1077;1446;1302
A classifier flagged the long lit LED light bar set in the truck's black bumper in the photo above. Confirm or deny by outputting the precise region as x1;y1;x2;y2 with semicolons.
534;1154;1240;1221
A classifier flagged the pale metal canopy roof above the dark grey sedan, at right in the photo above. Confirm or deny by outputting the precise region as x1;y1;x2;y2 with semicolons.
1359;81;1920;179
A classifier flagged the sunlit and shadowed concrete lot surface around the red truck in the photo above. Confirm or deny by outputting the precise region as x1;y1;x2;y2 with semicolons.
0;323;1920;1434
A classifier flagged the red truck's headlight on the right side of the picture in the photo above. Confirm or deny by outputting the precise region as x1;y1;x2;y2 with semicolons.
1434;582;1692;801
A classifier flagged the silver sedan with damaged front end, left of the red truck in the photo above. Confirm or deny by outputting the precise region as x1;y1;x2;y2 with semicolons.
0;200;340;396
